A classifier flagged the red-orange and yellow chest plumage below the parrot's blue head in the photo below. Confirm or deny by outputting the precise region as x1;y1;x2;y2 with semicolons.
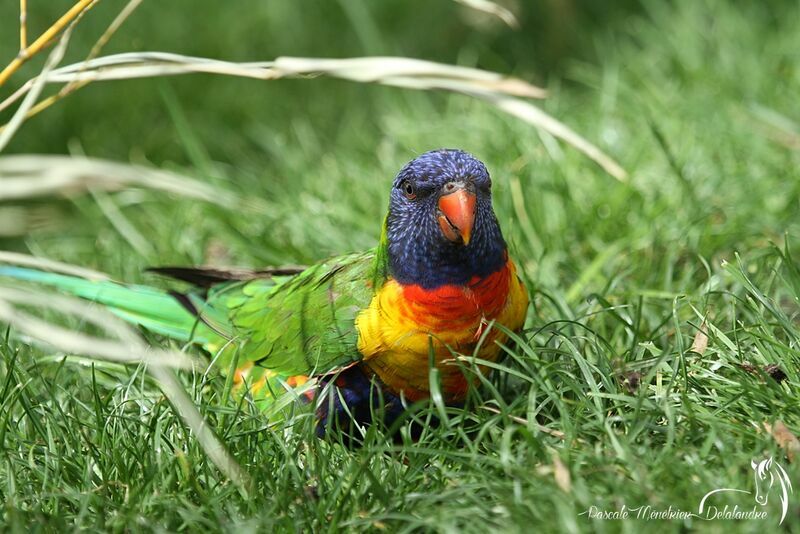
356;261;528;400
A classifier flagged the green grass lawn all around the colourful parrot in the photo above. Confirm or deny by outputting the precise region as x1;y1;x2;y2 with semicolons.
0;0;800;532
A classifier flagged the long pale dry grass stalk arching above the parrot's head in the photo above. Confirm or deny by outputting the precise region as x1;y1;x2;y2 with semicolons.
0;52;627;180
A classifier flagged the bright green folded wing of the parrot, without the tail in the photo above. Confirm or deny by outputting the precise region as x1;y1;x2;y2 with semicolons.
195;252;375;376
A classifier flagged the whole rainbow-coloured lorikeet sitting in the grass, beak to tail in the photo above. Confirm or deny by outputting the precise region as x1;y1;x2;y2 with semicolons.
0;150;528;432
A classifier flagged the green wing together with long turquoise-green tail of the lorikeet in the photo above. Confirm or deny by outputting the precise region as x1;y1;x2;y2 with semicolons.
0;249;386;384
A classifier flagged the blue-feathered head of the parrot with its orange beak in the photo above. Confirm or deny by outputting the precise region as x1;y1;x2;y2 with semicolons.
386;149;506;289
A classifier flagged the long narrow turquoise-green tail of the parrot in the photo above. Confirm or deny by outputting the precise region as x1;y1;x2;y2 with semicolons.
0;265;210;343
